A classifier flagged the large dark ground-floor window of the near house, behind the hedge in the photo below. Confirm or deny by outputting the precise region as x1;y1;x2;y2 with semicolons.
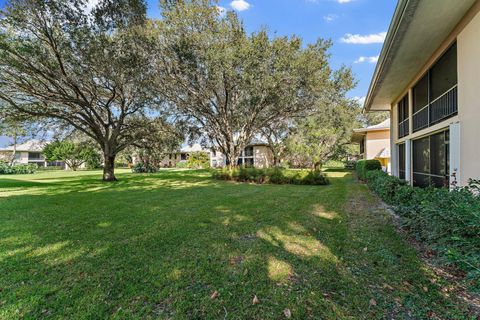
413;130;450;187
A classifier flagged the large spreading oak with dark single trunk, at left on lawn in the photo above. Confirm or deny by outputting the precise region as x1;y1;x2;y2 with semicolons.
0;0;167;181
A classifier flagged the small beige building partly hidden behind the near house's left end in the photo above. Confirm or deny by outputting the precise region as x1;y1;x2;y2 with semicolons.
352;119;391;173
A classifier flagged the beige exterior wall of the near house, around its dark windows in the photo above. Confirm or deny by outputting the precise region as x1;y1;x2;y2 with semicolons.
390;2;480;186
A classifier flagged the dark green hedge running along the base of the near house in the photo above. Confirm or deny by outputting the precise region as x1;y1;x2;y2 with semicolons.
367;171;480;291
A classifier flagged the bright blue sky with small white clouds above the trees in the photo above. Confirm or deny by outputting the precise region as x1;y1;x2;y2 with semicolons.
0;0;397;146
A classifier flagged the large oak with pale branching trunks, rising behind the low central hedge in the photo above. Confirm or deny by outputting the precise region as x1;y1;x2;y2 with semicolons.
155;0;352;168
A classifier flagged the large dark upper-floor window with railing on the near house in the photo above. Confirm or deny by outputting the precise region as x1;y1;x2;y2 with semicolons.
413;43;458;132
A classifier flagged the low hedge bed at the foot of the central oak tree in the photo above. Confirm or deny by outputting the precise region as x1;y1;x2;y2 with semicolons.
213;167;330;185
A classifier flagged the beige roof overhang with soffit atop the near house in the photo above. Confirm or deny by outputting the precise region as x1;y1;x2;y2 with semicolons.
364;0;478;112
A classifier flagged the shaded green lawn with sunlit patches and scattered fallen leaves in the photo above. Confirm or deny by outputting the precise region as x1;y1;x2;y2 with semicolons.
0;170;472;319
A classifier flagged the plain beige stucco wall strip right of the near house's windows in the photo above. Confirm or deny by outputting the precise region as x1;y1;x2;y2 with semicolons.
457;9;480;185
